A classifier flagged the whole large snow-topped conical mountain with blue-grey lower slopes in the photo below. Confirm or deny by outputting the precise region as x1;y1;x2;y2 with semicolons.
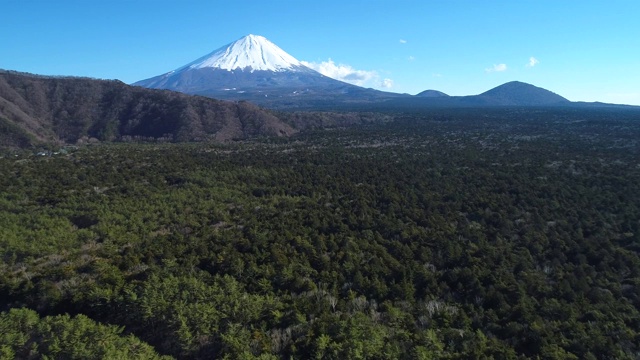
133;35;400;107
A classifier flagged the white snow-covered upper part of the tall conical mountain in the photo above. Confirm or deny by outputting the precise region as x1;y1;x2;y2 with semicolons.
178;35;303;72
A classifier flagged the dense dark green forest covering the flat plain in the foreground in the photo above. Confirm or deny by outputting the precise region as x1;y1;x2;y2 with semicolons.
0;109;640;359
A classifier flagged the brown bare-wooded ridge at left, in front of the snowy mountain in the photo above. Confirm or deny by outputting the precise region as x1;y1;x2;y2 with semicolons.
0;71;297;147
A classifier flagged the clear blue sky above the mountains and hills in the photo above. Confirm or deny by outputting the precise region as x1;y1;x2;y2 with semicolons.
0;0;640;105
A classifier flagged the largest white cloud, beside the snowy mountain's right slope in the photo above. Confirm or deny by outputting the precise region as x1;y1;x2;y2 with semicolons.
301;59;393;87
